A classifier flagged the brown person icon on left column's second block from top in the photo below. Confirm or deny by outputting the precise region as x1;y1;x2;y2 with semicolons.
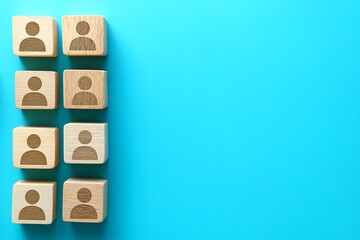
22;76;47;106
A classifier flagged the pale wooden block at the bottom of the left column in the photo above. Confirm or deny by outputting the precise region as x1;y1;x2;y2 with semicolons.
12;181;56;224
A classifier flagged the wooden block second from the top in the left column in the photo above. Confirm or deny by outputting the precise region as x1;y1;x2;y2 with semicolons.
15;71;59;109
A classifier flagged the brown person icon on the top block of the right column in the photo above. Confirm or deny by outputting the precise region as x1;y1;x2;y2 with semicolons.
70;21;96;51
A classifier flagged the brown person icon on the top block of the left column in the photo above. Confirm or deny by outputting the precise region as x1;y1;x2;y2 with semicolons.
19;22;46;52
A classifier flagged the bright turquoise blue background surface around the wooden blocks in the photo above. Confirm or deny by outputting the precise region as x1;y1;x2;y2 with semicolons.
0;0;360;240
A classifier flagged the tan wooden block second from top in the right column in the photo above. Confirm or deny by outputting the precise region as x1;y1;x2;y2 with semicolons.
64;70;108;109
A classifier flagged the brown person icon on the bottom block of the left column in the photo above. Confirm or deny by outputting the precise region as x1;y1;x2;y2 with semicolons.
19;190;45;220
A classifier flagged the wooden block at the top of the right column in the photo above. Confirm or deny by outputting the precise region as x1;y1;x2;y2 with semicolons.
62;16;107;56
